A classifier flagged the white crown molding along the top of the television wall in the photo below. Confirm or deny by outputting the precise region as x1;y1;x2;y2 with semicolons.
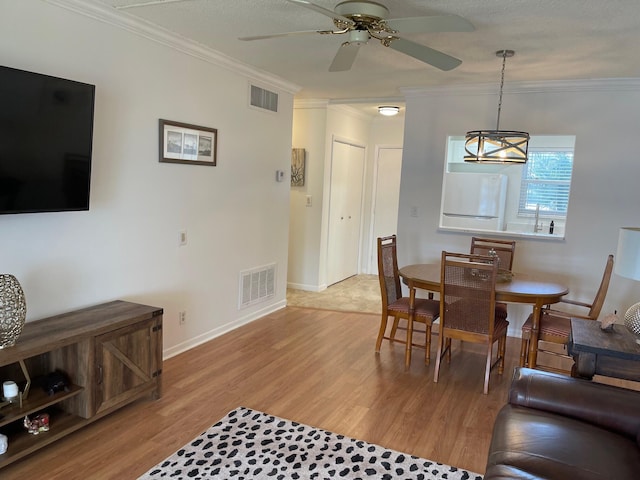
45;0;301;95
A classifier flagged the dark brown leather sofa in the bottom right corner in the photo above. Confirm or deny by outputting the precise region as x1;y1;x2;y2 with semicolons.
484;368;640;480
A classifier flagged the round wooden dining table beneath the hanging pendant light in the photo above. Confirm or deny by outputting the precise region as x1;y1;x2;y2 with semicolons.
399;263;569;368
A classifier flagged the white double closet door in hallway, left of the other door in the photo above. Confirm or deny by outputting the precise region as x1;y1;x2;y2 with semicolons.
327;141;365;285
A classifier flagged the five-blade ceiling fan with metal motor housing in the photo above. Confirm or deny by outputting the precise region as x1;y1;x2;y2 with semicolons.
239;0;474;72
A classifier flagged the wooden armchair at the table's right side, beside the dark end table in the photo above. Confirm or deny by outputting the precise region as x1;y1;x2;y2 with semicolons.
520;255;613;373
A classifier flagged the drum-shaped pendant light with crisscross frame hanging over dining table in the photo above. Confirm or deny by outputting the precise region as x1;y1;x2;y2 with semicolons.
464;50;529;163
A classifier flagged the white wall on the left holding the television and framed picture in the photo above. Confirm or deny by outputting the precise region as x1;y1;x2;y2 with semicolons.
0;0;296;355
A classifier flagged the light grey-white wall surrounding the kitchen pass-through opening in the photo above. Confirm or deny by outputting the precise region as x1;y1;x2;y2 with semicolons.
398;79;640;335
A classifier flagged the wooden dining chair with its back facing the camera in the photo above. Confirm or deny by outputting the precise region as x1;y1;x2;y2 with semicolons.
433;252;509;394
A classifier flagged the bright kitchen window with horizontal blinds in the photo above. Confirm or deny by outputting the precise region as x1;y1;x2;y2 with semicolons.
518;147;573;219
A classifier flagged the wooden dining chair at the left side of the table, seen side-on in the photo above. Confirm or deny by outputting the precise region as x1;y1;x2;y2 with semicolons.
376;235;440;367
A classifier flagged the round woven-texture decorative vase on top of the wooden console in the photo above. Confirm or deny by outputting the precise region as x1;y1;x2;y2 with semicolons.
0;273;27;349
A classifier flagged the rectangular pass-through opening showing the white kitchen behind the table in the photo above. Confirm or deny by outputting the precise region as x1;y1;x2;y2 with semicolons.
438;135;576;239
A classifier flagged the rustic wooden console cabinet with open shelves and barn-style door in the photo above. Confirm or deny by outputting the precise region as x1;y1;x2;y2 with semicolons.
0;300;163;468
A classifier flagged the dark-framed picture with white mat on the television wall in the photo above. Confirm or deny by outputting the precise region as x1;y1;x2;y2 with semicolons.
160;118;218;167
